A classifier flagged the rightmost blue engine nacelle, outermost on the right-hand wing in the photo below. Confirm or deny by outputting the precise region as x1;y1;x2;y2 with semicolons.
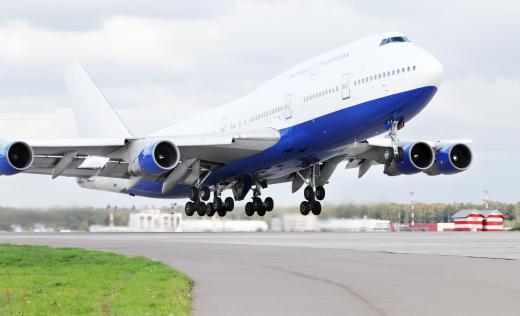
425;144;473;176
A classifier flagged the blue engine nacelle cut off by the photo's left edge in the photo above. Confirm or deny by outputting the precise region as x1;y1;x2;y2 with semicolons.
0;142;34;176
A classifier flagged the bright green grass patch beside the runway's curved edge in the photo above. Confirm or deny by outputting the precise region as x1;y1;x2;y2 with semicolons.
0;244;192;316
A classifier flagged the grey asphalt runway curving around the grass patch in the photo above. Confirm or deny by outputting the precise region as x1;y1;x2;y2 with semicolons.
0;232;520;315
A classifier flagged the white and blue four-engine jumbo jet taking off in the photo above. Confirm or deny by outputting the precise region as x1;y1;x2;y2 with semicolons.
0;32;472;216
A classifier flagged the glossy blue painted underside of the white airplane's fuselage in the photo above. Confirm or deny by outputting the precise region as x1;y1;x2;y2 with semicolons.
124;87;437;198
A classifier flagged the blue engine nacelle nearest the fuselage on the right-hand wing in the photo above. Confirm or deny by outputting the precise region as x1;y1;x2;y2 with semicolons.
384;142;435;176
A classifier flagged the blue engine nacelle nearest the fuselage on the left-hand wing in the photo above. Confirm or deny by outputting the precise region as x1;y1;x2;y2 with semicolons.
130;140;180;176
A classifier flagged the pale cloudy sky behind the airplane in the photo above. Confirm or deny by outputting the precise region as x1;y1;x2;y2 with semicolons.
0;0;520;207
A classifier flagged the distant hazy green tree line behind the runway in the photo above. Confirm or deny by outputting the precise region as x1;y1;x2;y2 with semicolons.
0;201;520;231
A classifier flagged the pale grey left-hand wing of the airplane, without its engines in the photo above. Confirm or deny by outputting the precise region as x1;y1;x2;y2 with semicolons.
16;128;280;178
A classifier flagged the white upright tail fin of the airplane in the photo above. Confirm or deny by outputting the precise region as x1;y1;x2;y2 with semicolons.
64;61;132;138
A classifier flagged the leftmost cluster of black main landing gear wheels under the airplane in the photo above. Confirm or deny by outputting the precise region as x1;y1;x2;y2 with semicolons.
184;187;235;217
